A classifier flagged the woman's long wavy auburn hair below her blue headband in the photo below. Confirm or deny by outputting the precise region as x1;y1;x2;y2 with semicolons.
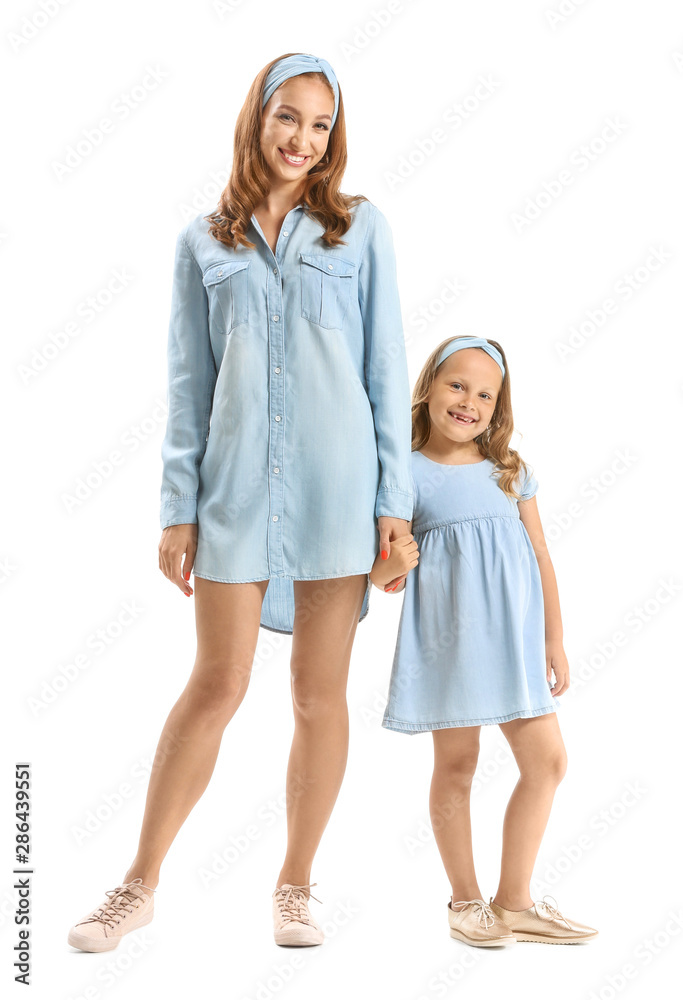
204;52;368;249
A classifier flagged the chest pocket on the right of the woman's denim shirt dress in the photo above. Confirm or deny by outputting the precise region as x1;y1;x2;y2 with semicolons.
300;253;356;330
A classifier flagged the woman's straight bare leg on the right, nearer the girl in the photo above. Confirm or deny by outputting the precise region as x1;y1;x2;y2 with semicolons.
277;575;367;896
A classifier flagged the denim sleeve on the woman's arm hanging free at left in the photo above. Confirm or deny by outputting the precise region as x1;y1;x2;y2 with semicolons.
160;232;217;528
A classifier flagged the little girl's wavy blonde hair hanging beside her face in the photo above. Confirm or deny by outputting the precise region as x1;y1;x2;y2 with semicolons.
411;337;530;500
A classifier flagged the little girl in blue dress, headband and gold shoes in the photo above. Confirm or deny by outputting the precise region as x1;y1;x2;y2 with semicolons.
370;337;598;947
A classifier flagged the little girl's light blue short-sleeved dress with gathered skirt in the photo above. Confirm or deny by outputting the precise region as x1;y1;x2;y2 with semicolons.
382;451;560;734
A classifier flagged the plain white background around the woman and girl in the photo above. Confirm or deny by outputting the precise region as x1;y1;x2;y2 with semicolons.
0;0;683;1000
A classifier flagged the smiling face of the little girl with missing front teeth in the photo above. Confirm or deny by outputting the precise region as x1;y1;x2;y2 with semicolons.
427;347;503;451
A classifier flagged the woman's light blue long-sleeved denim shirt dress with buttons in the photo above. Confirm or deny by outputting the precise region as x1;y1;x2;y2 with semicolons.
161;201;413;634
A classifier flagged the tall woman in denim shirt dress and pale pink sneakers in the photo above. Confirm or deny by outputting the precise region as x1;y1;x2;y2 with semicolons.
69;53;413;952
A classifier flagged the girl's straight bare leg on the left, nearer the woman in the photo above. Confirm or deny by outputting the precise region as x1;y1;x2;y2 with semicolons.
429;726;483;910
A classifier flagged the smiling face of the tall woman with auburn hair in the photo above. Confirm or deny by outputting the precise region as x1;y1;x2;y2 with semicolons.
261;76;334;183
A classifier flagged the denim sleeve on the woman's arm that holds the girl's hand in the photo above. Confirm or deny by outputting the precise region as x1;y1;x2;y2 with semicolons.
358;205;413;521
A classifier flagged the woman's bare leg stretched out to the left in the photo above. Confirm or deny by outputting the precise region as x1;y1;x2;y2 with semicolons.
123;577;268;889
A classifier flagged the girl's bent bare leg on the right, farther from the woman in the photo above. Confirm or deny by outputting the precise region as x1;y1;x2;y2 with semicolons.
493;712;567;910
